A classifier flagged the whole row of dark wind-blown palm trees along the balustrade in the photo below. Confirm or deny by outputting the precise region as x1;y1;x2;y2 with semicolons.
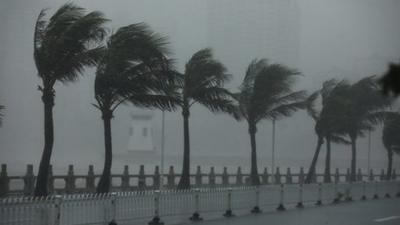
20;3;398;196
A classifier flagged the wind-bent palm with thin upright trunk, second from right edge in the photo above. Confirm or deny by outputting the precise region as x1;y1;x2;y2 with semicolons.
342;76;392;181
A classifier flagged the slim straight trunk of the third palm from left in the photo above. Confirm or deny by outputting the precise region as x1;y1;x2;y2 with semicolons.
178;107;190;189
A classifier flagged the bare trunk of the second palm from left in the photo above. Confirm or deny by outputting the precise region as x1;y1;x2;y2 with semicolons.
96;110;113;193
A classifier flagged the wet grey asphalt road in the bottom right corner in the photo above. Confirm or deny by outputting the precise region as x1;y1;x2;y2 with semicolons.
181;198;400;225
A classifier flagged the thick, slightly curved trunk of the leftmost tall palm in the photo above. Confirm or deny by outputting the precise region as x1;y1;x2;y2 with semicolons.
35;88;54;196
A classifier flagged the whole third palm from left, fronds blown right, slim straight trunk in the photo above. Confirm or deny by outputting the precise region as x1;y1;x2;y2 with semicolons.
178;48;235;189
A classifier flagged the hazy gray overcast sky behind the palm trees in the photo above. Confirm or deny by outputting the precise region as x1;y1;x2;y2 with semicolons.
0;0;400;174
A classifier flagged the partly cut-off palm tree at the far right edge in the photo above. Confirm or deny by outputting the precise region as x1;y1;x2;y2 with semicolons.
382;113;400;180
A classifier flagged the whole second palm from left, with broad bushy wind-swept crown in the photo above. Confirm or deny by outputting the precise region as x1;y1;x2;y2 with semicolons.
94;23;176;193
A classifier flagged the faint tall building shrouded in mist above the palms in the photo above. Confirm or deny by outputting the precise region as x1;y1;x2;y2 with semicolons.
207;0;300;79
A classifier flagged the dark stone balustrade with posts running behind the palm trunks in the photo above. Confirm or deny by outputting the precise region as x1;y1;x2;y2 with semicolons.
0;164;397;197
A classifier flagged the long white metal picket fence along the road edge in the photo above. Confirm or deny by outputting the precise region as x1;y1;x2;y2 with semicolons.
0;181;400;225
